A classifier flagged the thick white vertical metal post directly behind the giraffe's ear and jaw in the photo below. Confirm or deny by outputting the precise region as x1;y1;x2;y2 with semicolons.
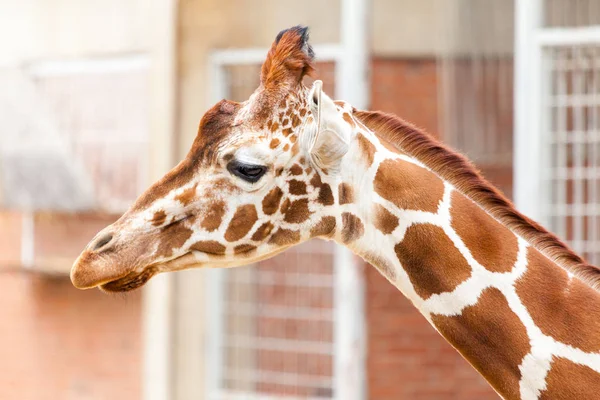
334;0;370;400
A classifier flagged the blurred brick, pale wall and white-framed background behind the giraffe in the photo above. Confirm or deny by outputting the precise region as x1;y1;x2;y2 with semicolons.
0;0;600;400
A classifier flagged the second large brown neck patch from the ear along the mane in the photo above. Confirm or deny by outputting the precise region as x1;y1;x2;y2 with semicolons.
450;191;519;272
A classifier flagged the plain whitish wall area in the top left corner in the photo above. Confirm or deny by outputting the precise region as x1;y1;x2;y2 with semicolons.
0;0;151;66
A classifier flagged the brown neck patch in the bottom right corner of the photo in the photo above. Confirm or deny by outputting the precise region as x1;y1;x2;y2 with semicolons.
539;357;600;400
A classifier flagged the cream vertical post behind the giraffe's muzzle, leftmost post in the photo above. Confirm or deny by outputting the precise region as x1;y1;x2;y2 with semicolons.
141;0;177;400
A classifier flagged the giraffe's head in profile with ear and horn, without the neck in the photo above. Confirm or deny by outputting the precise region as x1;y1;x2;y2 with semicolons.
71;27;358;291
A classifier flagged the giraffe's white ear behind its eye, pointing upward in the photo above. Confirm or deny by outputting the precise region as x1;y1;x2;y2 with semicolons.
309;81;351;169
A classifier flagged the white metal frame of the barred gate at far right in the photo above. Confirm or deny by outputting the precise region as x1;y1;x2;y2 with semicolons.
513;0;600;223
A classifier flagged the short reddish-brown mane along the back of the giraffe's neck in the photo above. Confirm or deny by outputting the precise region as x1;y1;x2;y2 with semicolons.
354;110;600;289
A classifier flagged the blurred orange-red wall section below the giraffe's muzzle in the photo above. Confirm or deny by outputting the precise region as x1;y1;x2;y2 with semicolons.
0;272;141;400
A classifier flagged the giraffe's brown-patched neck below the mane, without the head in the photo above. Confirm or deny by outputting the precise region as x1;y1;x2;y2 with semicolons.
336;121;600;399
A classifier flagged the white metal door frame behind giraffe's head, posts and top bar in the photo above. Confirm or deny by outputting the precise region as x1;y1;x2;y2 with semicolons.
206;4;369;400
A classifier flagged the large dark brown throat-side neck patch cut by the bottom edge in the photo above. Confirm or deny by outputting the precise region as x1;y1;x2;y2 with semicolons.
431;288;531;399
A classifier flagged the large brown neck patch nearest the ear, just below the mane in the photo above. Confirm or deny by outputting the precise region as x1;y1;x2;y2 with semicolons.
374;160;444;212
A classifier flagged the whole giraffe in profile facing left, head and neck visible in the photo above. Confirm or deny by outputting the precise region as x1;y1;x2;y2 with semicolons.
71;27;600;399
